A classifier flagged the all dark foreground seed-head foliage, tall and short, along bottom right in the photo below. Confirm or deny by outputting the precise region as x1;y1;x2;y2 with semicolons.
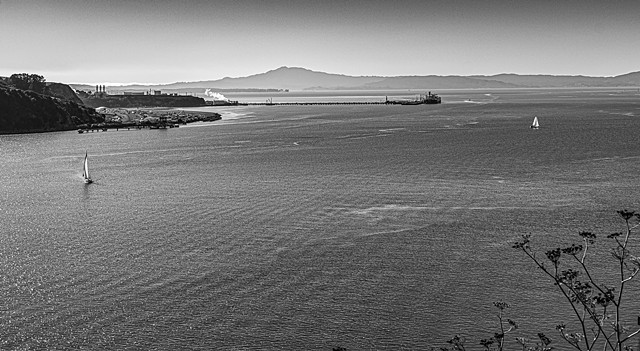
432;210;640;351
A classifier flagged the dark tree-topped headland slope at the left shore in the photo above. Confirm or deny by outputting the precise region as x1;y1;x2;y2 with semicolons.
0;80;104;134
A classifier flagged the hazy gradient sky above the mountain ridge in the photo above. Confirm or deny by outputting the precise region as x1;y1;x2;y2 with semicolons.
0;0;640;84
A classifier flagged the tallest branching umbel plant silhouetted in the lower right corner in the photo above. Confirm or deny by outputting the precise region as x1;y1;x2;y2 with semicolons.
513;210;640;351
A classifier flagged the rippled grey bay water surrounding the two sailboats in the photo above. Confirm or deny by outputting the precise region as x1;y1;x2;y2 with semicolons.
0;90;640;350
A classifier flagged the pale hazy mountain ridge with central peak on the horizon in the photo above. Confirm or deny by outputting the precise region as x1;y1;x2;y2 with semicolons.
70;67;640;91
